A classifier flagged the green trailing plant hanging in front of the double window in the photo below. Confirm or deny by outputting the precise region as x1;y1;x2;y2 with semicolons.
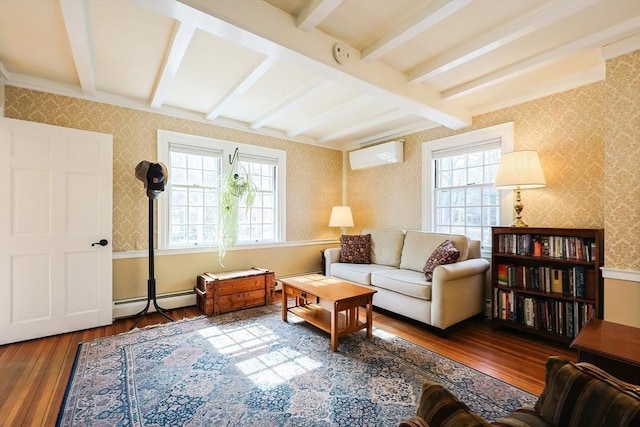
218;172;257;267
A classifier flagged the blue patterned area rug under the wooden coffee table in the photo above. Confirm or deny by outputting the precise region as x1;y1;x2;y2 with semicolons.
58;305;536;427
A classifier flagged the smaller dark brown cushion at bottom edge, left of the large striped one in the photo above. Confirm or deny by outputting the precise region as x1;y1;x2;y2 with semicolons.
416;382;491;427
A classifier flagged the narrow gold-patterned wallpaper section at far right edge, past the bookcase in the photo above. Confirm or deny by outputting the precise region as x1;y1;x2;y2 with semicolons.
604;51;640;271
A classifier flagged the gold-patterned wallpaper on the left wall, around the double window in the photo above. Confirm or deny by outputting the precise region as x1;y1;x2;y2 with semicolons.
5;86;342;252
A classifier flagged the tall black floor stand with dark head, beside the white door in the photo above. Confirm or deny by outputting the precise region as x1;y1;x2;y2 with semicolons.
131;160;173;329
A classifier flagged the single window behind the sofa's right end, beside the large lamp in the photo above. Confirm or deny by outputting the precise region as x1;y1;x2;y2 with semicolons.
423;123;513;250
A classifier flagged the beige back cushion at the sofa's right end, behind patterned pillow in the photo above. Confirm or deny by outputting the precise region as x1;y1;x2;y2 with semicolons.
400;230;469;272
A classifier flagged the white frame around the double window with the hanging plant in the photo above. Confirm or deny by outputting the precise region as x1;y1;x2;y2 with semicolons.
157;129;287;251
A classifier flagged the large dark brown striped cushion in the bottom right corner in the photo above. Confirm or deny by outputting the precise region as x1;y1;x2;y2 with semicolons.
535;356;640;426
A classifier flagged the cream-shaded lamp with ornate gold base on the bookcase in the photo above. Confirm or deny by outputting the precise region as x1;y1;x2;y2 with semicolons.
494;150;547;227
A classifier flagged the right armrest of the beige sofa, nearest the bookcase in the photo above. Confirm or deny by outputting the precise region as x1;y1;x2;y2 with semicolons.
431;258;489;330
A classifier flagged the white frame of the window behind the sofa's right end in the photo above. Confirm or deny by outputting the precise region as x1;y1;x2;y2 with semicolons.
422;122;513;256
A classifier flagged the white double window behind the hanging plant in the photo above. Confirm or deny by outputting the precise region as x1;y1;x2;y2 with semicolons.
158;130;286;249
